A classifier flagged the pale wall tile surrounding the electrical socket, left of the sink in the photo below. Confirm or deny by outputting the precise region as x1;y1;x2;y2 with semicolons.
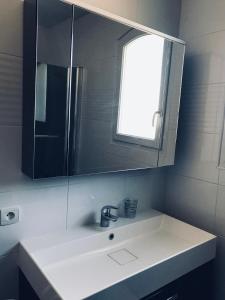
0;185;68;256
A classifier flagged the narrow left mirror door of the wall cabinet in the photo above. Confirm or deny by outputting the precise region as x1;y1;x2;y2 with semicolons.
24;0;73;178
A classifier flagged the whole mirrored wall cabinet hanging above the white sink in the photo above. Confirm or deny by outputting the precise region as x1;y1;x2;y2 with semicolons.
22;0;185;179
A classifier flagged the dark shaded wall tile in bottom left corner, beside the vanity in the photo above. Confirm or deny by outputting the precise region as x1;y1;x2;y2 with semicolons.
0;252;19;300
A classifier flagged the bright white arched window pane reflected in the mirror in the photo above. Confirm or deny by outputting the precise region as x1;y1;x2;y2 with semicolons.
116;35;171;147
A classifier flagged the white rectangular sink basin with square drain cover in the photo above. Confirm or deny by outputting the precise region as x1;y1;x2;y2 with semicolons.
19;211;216;300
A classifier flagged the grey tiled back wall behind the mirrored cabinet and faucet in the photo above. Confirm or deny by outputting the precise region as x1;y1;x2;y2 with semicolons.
0;0;180;300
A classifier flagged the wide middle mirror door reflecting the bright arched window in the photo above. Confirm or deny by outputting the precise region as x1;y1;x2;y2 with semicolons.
69;7;181;175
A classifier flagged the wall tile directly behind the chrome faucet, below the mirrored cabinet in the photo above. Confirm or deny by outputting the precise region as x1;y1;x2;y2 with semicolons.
67;170;164;229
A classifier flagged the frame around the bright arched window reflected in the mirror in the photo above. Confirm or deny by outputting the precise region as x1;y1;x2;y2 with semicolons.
113;29;172;149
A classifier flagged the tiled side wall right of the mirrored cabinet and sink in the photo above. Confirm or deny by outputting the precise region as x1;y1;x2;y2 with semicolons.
163;0;225;300
